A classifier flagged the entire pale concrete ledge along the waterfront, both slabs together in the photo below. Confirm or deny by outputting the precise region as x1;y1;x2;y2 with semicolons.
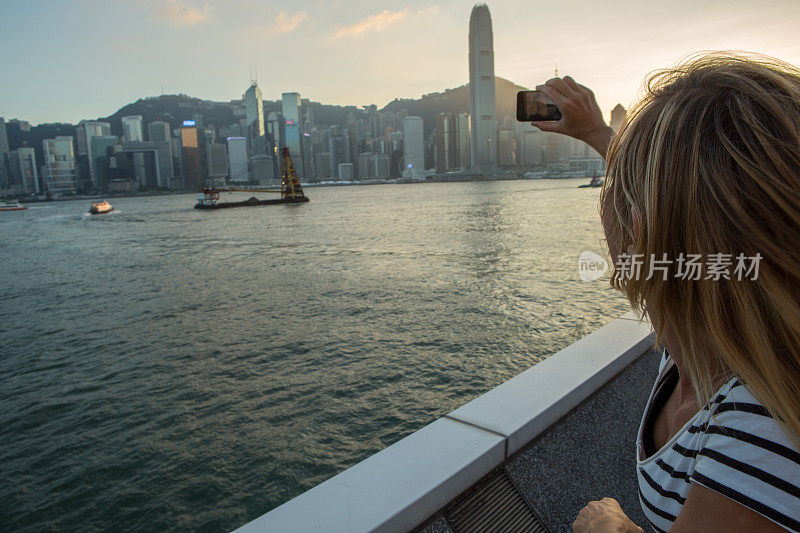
237;314;653;533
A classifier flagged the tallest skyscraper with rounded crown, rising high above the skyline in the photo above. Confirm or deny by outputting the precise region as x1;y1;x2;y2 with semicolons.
469;4;497;170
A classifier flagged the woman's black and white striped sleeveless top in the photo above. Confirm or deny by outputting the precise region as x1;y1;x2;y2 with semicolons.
636;351;800;531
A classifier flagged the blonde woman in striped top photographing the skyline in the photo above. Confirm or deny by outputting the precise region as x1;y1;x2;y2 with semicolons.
533;54;800;532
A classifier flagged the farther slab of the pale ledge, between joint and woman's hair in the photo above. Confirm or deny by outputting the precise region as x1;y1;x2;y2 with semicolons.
447;318;653;457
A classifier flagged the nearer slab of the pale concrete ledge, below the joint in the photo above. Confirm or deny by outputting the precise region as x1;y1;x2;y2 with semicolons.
236;418;504;533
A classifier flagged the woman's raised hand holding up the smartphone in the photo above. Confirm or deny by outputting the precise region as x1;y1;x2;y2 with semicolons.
531;76;614;158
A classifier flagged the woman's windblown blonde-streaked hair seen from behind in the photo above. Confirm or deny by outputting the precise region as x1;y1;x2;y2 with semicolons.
601;53;800;444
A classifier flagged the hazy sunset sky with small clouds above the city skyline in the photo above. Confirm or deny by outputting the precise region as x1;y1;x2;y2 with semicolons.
0;0;800;124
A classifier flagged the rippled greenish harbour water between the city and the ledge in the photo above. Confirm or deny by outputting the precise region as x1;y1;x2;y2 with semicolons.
0;180;626;531
